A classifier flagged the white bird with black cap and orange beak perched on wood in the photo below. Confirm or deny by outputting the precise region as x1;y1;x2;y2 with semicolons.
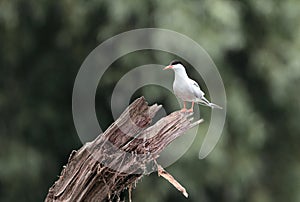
164;60;222;112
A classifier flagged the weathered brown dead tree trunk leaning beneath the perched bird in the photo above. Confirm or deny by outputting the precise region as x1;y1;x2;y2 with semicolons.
45;97;202;202
